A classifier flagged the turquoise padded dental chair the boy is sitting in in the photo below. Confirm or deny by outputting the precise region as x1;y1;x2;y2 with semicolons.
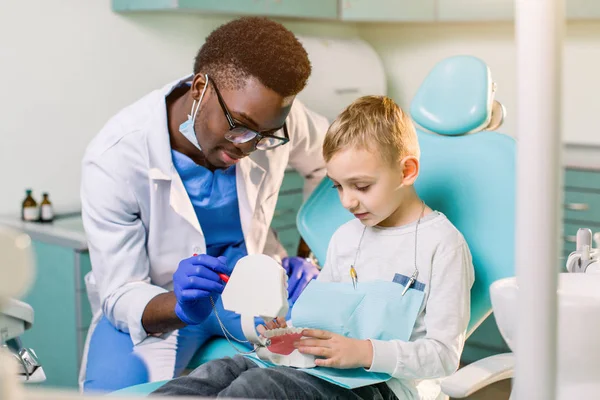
114;56;515;395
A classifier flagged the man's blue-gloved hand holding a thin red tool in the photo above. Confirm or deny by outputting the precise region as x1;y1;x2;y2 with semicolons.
173;254;231;325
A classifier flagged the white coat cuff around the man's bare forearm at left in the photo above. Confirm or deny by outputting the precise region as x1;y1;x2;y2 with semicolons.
119;284;168;346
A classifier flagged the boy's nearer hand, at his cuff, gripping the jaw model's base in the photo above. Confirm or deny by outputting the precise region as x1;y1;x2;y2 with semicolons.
294;329;373;369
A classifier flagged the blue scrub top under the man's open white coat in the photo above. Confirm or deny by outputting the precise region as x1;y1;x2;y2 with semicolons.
171;150;248;267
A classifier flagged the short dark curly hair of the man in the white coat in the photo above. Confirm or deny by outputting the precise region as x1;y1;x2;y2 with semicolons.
194;17;311;97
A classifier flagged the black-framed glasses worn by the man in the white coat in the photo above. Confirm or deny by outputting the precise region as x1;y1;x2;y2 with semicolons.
207;75;290;150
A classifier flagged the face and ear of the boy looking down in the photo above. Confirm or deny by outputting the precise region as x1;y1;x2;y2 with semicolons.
327;148;418;226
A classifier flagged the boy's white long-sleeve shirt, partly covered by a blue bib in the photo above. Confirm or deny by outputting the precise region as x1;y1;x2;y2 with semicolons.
318;212;474;399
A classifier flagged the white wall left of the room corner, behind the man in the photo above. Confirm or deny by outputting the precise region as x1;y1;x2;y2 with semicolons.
0;0;356;213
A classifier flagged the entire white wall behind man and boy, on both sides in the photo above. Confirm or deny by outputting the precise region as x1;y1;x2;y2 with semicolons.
0;0;600;214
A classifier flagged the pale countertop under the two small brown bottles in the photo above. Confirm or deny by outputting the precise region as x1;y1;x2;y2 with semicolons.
0;214;88;250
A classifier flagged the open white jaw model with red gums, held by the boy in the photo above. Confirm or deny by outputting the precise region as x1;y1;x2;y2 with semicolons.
221;254;315;368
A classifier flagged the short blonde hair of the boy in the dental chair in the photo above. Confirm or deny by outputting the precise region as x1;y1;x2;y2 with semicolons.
323;96;420;164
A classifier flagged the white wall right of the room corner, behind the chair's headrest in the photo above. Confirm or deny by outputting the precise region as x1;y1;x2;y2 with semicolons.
359;21;600;146
